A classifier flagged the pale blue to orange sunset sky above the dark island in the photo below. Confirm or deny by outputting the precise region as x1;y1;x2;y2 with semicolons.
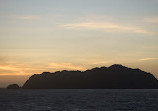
0;0;158;87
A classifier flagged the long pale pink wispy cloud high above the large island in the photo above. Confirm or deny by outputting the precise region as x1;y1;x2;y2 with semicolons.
60;22;153;35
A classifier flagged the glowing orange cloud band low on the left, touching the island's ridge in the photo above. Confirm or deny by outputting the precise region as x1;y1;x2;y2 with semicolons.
0;61;86;75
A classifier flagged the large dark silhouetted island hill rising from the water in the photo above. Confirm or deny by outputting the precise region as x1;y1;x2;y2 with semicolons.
22;64;158;89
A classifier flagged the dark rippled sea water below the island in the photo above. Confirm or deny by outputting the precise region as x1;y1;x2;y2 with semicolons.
0;89;158;111
